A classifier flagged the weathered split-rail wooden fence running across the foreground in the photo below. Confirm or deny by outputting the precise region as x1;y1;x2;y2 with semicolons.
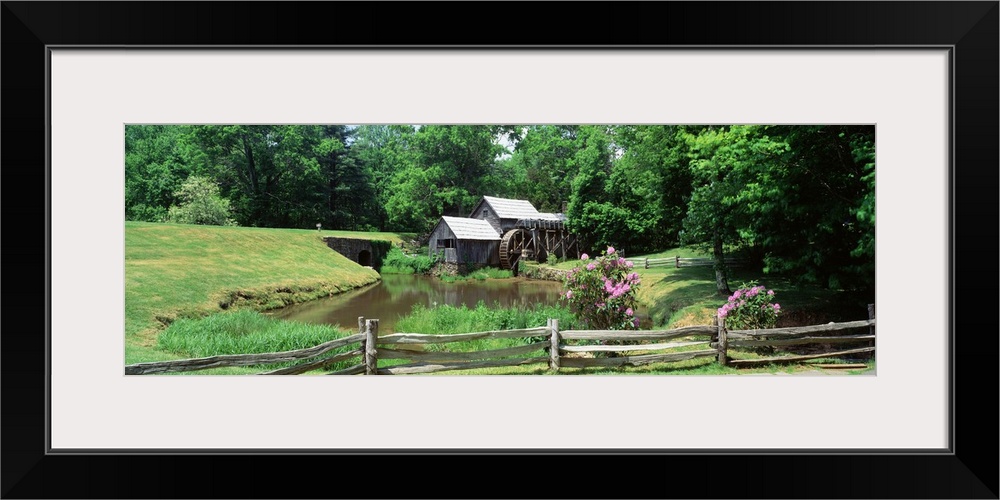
125;306;875;375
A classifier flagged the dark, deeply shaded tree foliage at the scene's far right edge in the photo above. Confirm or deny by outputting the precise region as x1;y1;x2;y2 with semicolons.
745;125;875;297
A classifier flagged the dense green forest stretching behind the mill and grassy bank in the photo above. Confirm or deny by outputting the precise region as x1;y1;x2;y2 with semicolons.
125;125;875;291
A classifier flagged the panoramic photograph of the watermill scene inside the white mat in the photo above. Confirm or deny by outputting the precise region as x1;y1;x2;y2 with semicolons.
124;124;876;376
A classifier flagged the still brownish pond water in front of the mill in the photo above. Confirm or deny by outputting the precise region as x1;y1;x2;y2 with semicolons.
270;274;562;333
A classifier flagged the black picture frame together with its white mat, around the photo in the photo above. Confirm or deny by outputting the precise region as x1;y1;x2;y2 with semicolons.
2;2;1000;498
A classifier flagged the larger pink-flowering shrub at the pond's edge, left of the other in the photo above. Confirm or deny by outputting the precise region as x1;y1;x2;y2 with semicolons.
562;247;640;330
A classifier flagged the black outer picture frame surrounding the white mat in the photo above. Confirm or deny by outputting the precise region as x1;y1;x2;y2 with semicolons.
0;1;1000;498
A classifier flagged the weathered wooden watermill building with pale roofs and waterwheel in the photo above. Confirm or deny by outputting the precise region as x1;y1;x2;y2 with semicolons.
429;196;580;272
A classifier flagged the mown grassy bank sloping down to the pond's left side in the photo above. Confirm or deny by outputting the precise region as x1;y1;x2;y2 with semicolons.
125;222;412;364
